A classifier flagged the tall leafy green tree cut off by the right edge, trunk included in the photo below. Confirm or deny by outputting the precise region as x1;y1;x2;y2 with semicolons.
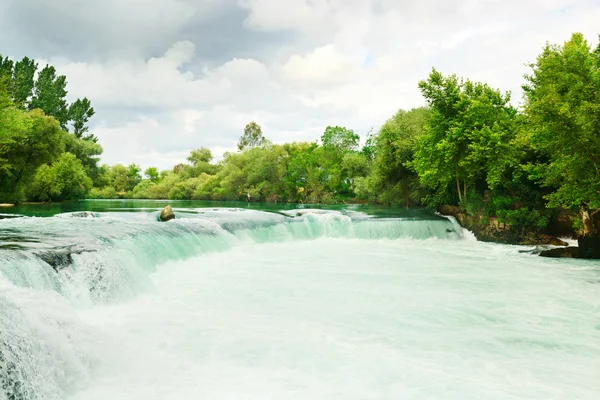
523;33;600;258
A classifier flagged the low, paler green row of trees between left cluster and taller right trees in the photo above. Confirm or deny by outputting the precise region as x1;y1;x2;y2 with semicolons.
91;122;373;203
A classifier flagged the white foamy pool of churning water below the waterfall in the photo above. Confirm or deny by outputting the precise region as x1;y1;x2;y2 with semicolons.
64;238;600;400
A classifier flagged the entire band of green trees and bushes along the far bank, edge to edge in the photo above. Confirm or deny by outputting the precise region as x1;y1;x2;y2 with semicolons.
0;34;600;244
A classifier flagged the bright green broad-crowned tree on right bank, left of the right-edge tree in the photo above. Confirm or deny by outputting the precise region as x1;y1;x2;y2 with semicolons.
412;69;517;203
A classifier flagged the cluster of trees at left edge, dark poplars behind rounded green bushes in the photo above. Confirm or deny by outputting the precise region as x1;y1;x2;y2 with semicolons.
0;55;102;202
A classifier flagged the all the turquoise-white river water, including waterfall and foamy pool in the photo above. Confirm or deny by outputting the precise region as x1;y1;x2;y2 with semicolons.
0;202;600;400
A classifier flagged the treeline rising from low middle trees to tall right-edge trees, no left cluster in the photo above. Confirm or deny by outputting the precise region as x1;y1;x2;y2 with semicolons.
92;34;600;247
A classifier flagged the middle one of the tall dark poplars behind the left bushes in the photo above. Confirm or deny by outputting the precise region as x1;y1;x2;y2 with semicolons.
29;65;69;130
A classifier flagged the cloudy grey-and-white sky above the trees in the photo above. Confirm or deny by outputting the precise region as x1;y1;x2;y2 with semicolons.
0;0;600;169
